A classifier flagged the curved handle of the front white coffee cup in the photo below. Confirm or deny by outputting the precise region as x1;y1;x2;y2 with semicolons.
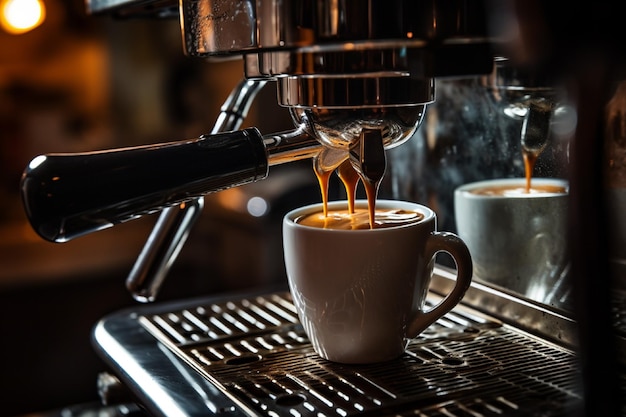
407;232;472;339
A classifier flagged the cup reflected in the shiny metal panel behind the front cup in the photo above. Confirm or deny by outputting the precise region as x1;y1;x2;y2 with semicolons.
454;178;568;303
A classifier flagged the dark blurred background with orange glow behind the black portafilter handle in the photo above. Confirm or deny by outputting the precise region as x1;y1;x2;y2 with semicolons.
0;0;320;416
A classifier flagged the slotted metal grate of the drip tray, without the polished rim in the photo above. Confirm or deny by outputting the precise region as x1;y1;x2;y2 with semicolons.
140;292;582;417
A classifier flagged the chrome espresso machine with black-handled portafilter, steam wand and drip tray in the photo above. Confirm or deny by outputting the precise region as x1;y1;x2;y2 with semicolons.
17;0;626;416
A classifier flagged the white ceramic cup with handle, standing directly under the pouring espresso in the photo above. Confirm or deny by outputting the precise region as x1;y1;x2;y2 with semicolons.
283;200;472;364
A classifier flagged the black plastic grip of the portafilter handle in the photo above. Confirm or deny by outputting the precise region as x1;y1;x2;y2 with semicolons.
21;128;269;242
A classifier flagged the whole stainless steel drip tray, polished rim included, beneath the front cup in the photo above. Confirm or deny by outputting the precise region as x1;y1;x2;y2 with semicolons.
94;270;582;416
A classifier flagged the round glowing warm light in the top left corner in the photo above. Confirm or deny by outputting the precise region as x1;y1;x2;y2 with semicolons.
0;0;46;35
